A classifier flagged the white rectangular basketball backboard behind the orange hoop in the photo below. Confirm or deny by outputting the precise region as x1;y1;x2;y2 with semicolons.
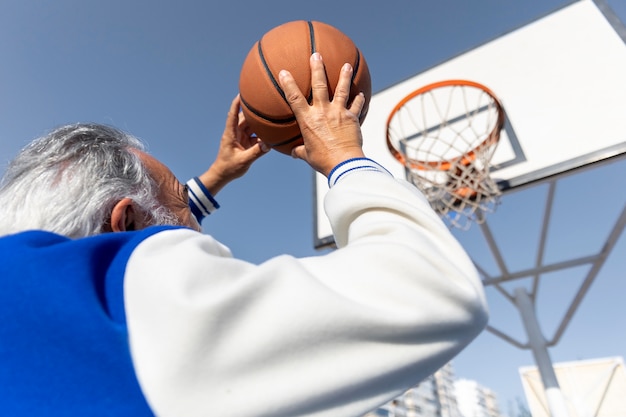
314;0;626;248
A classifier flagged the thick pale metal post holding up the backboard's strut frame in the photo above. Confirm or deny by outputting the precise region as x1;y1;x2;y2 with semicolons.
515;287;569;417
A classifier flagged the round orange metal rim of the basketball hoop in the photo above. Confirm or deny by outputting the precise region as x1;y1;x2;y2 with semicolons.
386;80;504;171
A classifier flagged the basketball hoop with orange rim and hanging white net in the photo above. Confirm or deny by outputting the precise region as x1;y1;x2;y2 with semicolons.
387;80;504;229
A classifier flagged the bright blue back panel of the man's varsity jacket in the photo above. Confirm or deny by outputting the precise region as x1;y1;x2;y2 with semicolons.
0;227;179;417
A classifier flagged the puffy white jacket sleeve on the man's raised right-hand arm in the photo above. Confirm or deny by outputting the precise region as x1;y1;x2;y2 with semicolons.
125;167;487;417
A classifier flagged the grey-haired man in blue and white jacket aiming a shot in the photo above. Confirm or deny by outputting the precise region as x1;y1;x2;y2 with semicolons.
0;54;487;417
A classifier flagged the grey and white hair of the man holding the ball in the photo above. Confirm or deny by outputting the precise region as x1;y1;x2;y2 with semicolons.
0;123;179;238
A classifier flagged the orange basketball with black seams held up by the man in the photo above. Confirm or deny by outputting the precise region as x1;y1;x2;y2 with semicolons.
239;20;372;154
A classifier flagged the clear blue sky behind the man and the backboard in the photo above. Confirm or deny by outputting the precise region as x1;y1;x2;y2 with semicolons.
0;0;626;411
